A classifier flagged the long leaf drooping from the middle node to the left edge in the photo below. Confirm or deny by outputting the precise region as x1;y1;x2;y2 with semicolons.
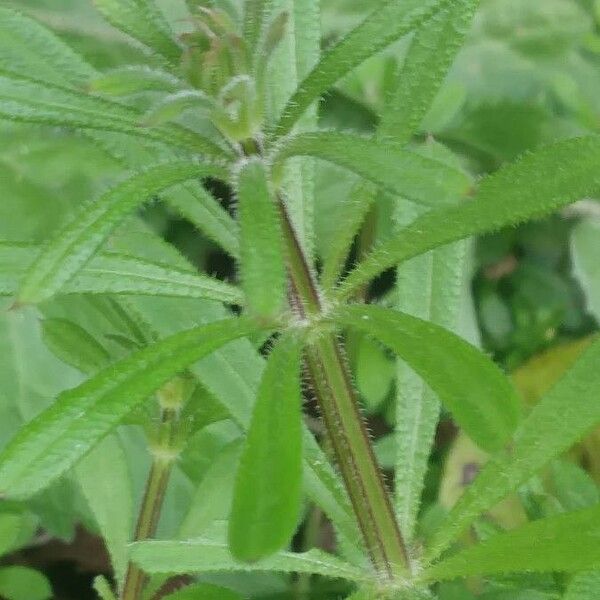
0;318;257;498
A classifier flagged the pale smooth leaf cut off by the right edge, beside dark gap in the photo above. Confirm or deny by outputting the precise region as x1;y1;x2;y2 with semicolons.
571;219;600;319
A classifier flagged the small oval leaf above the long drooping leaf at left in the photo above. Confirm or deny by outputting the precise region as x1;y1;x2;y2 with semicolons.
42;319;110;374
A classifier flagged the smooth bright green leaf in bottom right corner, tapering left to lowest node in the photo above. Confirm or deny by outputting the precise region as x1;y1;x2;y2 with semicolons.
422;506;600;581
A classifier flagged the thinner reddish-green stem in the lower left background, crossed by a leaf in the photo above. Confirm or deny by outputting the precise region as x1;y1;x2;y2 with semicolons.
121;408;179;600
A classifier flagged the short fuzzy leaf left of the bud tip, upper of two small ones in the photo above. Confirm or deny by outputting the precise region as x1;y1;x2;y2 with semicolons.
88;65;183;96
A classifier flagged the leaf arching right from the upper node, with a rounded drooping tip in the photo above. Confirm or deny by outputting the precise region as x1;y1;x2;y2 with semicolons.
274;132;471;206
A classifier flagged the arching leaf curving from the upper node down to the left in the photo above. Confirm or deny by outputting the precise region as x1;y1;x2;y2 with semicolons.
18;161;225;303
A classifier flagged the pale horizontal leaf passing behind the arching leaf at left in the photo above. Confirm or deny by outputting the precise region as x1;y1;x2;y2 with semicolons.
0;241;244;304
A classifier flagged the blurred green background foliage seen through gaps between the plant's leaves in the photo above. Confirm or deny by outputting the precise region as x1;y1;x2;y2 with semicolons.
0;0;600;600
